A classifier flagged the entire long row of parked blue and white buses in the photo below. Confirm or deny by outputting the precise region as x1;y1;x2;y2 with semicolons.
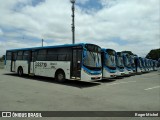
5;43;158;82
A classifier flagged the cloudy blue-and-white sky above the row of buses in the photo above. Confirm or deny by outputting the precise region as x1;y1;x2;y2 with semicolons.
0;0;160;57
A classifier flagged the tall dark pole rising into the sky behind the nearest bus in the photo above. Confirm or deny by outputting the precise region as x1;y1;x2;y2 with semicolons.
70;0;76;44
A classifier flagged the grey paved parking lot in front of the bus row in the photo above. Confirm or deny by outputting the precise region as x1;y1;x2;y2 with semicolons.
0;69;160;119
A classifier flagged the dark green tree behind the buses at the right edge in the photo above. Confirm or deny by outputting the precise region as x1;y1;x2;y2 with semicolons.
146;49;160;60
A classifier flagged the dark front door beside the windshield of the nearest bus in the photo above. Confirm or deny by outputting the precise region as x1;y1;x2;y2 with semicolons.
71;48;82;79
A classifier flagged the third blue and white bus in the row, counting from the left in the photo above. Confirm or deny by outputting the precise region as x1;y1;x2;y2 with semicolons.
116;52;125;77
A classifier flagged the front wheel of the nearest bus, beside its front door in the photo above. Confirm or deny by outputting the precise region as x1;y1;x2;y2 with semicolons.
55;70;66;83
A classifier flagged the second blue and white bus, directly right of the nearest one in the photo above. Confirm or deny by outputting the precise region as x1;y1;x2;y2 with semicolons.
101;49;116;78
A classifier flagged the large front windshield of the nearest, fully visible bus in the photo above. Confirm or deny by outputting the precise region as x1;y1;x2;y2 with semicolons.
83;45;102;69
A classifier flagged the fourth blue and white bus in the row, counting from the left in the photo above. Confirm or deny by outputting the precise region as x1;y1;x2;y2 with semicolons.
123;53;133;75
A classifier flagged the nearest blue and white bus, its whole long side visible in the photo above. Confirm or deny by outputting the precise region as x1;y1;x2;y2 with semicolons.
5;43;102;82
